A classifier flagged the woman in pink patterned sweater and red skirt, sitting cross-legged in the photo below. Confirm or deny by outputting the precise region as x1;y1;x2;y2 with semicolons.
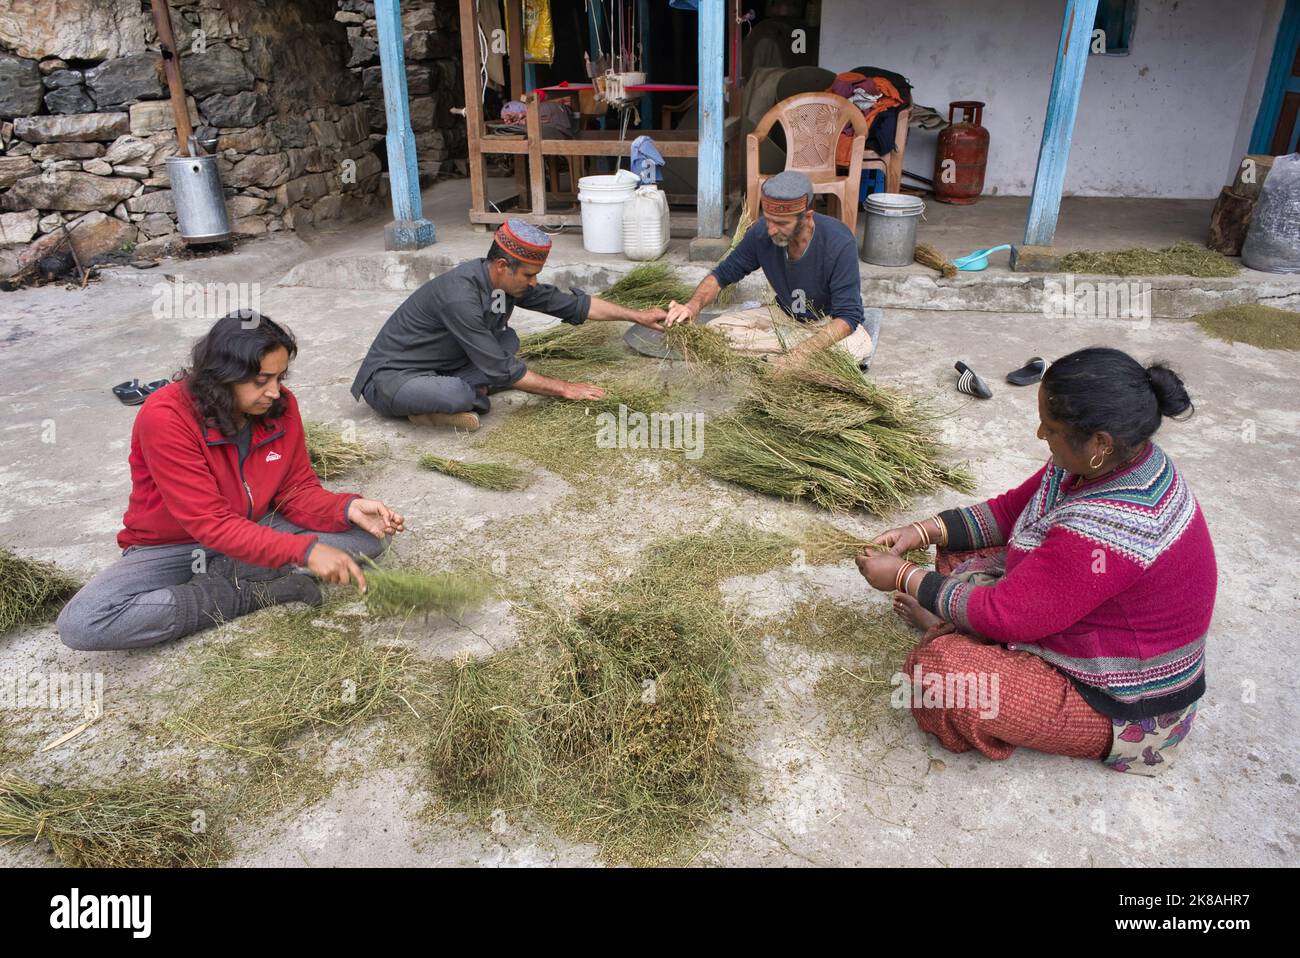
858;347;1217;773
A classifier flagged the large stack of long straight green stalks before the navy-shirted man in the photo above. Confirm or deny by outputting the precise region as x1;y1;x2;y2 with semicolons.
699;347;974;513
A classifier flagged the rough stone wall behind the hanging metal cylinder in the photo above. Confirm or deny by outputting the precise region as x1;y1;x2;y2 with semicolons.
0;0;384;272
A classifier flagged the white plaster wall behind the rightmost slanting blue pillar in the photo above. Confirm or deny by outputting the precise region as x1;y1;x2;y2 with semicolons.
819;0;1284;198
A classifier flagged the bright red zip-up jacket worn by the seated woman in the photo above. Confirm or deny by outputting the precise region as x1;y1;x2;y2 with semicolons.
117;382;358;568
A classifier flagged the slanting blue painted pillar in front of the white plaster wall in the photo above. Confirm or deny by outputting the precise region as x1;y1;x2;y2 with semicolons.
1024;0;1097;246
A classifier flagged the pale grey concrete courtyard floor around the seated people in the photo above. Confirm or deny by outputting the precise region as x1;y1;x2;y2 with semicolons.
0;191;1300;866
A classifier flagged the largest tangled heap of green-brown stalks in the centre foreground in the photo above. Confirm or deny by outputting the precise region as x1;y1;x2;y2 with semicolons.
429;524;790;863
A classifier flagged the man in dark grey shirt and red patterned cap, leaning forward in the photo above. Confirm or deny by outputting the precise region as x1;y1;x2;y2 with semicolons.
352;220;667;432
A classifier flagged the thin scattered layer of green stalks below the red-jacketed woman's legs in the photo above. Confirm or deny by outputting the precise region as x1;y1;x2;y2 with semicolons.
166;608;431;759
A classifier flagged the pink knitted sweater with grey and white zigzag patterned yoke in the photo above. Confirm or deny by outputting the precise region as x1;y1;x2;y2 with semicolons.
918;443;1217;718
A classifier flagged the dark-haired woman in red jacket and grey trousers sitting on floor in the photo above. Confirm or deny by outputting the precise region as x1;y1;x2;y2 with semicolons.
59;311;403;651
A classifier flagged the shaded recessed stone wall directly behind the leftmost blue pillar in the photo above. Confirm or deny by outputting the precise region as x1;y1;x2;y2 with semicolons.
337;0;468;183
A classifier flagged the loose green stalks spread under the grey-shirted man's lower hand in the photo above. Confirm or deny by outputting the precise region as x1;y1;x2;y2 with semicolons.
476;381;671;480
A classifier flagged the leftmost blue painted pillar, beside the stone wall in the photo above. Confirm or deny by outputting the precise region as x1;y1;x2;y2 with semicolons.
374;0;436;250
